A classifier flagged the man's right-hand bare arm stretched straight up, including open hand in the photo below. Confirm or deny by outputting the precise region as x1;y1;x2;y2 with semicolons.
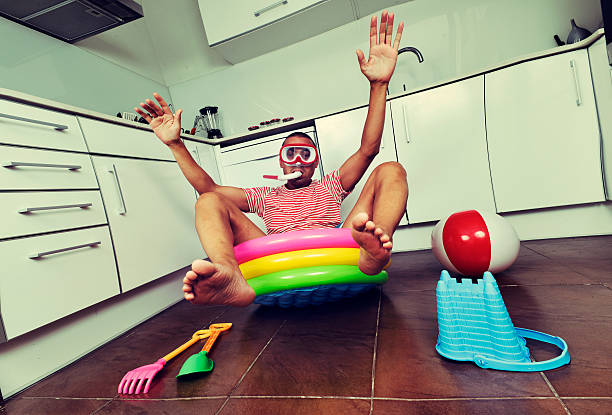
340;11;404;191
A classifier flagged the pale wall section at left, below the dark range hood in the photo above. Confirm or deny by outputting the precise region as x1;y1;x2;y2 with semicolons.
0;17;169;115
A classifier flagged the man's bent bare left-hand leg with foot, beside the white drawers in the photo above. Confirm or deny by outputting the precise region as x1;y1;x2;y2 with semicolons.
183;192;265;306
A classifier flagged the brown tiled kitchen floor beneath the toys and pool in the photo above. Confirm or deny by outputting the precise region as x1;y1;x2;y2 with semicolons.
0;236;612;415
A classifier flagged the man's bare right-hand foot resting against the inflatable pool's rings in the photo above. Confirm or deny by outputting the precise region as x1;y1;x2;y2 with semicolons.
351;212;393;275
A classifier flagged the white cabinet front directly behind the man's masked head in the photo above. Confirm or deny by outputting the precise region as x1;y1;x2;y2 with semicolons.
219;129;321;232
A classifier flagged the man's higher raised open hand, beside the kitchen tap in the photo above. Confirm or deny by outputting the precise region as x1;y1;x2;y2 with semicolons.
357;10;404;83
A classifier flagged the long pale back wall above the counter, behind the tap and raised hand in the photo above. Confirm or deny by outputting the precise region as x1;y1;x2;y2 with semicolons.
169;0;601;136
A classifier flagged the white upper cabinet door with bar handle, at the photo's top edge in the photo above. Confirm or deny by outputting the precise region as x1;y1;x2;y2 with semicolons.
198;0;319;45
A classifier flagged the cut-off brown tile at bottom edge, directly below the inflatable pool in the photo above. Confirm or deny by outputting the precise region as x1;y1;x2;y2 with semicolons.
221;398;370;415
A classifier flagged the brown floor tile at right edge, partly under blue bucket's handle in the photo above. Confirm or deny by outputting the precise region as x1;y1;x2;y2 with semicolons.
502;285;612;397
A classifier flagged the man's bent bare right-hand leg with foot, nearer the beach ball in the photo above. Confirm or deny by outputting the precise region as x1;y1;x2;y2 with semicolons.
342;162;408;275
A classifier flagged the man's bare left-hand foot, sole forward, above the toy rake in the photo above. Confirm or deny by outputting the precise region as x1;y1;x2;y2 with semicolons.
183;259;255;306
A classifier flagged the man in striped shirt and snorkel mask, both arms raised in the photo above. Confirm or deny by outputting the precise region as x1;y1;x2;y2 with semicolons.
135;11;408;306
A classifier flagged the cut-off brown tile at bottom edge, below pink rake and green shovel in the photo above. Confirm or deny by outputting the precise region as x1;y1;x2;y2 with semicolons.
95;398;226;415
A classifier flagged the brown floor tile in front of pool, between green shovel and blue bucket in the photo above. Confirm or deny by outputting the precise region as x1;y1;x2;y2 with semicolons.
233;322;374;397
